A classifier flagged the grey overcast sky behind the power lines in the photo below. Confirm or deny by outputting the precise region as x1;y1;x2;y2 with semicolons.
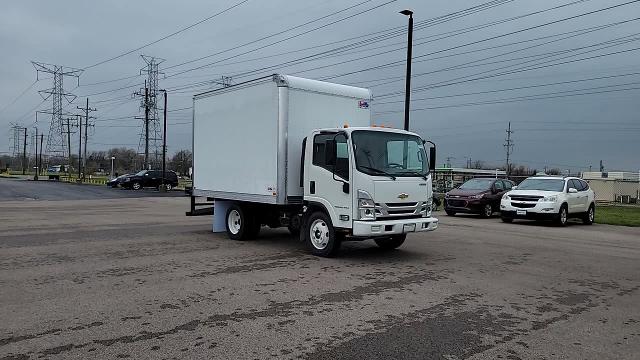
0;0;640;171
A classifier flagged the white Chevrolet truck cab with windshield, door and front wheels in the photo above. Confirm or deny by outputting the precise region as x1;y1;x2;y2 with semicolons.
301;127;438;256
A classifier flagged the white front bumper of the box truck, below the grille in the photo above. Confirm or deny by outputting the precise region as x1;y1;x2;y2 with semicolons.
353;217;438;237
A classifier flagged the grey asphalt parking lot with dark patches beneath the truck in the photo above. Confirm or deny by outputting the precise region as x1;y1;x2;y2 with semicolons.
0;181;640;359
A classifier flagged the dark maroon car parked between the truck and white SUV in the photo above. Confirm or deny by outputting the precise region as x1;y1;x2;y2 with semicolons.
444;178;513;218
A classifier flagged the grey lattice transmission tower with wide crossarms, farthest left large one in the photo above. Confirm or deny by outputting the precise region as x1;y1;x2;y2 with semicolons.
31;61;83;163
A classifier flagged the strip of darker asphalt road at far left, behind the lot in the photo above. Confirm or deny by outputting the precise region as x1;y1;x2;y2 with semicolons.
0;178;184;201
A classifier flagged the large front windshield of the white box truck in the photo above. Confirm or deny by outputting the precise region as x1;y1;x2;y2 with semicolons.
352;130;429;177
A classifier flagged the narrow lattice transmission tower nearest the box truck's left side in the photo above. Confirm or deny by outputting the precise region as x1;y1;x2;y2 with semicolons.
134;55;164;169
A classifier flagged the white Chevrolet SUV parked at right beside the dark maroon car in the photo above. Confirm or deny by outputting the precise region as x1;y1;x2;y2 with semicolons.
500;176;596;226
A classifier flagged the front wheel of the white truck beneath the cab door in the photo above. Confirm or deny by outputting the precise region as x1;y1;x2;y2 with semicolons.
304;211;340;257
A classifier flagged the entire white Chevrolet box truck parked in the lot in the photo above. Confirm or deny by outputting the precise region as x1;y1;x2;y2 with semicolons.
192;75;438;256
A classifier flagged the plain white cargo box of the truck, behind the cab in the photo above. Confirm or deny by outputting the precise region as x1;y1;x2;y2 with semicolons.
193;75;371;205
